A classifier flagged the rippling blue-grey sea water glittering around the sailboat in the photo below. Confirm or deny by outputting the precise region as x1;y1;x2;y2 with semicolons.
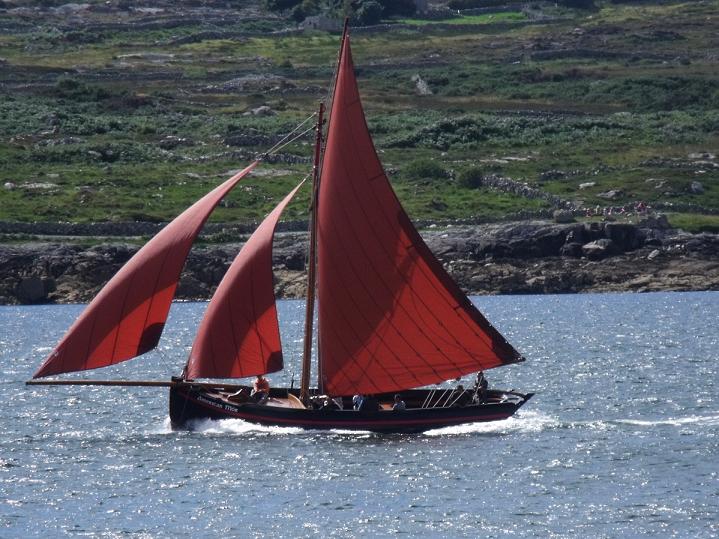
0;293;719;538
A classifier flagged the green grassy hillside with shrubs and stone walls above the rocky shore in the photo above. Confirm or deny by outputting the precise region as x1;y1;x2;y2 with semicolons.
0;0;719;231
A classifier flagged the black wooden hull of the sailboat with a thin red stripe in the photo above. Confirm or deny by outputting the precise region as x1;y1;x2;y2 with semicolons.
170;385;533;433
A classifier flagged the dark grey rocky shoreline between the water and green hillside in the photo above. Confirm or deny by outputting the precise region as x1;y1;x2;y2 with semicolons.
0;218;719;305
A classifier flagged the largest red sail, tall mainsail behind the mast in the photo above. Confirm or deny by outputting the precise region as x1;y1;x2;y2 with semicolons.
318;33;523;395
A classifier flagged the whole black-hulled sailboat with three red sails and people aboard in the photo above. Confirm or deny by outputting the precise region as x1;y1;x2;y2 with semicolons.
28;25;533;432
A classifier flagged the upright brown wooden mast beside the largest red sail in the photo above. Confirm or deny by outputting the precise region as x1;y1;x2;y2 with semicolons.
300;103;325;404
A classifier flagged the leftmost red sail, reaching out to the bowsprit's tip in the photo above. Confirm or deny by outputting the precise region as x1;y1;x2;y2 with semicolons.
33;162;257;378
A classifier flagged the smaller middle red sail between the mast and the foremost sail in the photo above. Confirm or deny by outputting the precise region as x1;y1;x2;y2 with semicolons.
186;182;304;379
